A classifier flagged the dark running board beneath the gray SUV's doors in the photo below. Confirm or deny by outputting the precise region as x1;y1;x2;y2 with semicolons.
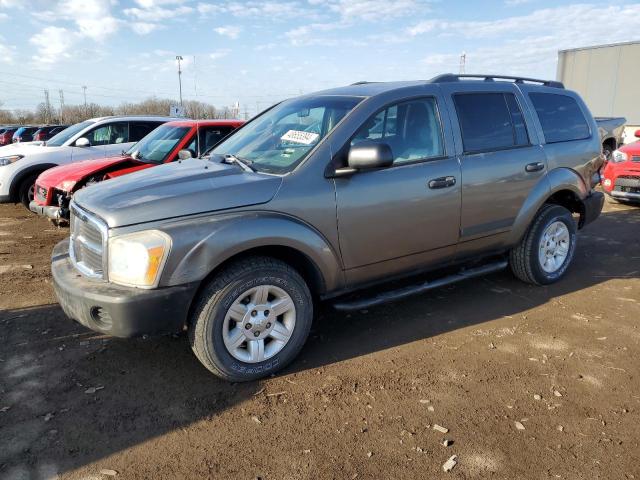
333;260;509;311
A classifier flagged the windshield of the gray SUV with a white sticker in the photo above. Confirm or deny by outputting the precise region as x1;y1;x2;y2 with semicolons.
212;96;362;174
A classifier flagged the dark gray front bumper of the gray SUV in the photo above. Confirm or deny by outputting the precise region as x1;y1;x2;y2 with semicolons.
51;240;198;337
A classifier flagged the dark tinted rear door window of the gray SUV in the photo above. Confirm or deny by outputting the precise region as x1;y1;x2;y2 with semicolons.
453;93;529;153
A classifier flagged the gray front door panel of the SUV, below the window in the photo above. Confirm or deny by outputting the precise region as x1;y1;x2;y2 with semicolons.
336;158;460;269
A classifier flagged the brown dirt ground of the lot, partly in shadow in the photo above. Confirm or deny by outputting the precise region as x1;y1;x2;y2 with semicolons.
0;200;640;480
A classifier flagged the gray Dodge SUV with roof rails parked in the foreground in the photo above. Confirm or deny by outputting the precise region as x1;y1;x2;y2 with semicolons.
52;74;604;381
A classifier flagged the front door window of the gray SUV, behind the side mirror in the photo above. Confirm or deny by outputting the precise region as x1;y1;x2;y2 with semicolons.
351;98;444;164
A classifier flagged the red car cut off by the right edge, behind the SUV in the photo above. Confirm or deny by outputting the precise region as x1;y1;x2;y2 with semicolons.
602;130;640;202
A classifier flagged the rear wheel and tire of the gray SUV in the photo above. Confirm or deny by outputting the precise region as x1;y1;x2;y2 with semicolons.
509;205;576;285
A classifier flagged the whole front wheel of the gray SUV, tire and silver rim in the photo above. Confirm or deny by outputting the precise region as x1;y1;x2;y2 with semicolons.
189;257;313;382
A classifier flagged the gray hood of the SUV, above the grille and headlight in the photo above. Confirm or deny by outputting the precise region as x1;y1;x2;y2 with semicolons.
74;159;282;228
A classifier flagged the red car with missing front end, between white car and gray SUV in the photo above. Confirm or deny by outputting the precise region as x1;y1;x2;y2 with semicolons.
29;120;244;221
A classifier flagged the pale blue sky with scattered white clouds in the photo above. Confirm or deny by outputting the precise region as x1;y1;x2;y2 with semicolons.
0;0;640;114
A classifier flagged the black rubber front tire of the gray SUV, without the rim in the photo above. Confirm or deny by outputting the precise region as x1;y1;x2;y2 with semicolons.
188;257;313;382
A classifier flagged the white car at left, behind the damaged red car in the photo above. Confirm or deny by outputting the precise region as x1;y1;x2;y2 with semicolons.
0;116;178;208
